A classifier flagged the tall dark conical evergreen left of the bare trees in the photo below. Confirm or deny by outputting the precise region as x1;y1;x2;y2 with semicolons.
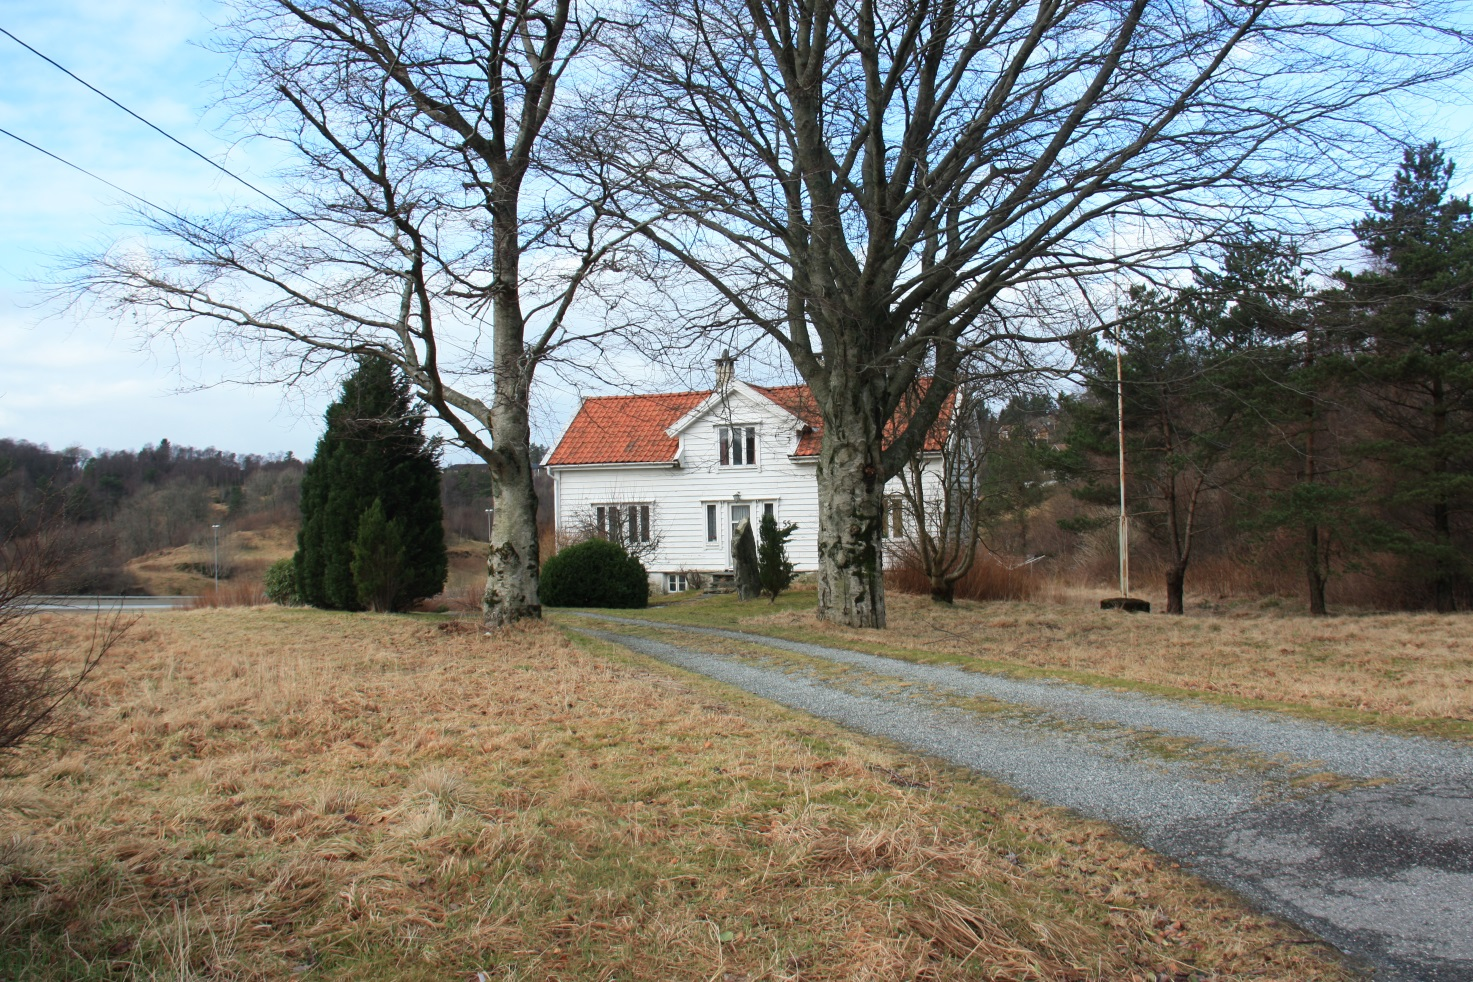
295;358;446;611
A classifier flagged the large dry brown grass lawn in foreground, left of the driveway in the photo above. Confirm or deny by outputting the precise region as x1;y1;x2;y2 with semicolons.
0;608;1348;982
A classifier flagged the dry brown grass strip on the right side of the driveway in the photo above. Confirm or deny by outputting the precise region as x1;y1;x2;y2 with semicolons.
577;587;1473;739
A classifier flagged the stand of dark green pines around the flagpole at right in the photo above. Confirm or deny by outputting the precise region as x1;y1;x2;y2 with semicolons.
1058;143;1473;614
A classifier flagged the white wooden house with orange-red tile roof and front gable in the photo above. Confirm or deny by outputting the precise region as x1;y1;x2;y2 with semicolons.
545;356;935;593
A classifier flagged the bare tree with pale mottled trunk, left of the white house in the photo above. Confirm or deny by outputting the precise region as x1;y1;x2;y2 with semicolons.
80;0;639;626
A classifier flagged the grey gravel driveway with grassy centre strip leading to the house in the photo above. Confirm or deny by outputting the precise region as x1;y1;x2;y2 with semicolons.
576;615;1473;982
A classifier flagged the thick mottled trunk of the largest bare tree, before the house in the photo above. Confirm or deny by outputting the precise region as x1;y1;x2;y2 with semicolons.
818;411;885;627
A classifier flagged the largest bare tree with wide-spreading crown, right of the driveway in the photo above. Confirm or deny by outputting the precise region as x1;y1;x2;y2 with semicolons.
574;0;1469;627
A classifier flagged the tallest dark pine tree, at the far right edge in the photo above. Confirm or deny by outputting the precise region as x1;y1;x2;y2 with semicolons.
1339;143;1473;611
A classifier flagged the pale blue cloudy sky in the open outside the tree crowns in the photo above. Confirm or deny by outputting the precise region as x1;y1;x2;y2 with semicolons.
0;0;1473;456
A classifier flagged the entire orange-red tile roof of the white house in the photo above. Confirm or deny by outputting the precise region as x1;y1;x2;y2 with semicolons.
546;386;955;467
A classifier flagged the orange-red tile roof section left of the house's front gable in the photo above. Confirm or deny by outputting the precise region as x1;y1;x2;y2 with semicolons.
546;392;711;467
